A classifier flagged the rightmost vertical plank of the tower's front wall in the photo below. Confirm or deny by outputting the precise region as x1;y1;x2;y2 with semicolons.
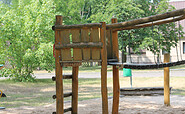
90;28;100;60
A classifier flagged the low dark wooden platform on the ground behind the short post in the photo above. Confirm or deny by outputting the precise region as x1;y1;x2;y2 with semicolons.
120;87;172;96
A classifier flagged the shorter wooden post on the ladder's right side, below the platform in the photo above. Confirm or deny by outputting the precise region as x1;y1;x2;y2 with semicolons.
71;66;79;114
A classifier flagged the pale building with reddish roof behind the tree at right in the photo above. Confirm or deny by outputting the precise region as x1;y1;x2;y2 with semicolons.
120;1;185;63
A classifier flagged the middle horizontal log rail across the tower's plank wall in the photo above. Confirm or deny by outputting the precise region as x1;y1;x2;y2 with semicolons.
55;42;103;49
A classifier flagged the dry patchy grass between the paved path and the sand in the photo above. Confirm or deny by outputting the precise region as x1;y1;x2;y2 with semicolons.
0;77;185;108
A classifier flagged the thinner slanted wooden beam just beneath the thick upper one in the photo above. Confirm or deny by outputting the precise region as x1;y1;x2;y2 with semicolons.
113;15;185;31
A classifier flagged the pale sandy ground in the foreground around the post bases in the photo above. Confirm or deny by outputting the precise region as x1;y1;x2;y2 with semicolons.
0;96;185;114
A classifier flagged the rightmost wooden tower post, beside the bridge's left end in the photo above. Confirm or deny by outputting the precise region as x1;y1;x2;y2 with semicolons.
111;18;120;114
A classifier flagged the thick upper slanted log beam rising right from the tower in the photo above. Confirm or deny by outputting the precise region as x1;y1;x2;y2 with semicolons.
106;8;185;29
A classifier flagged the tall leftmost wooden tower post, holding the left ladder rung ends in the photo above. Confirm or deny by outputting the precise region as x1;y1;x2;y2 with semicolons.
55;15;64;114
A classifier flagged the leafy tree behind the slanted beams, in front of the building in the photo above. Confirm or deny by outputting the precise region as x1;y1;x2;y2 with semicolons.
90;0;183;60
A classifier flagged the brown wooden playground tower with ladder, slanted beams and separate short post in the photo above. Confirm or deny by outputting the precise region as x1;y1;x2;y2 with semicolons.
52;9;185;114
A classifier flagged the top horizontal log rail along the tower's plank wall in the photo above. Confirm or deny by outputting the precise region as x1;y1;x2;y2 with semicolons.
52;23;102;30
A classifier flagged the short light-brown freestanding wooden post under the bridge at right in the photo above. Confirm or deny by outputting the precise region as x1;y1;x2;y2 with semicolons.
164;53;170;106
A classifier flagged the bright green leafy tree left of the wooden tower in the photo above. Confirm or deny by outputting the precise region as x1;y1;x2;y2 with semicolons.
0;0;55;81
